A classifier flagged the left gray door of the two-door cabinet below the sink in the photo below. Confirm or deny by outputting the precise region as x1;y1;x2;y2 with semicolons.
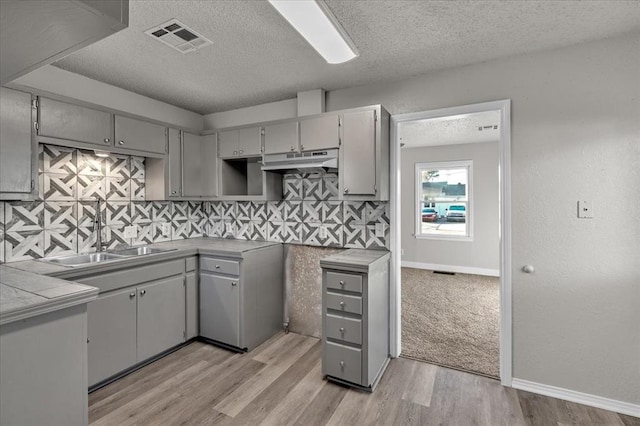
87;289;137;386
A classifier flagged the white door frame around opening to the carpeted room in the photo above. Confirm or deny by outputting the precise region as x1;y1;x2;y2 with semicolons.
389;99;513;386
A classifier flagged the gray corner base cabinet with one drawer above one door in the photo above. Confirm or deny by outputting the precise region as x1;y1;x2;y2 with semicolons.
200;245;284;351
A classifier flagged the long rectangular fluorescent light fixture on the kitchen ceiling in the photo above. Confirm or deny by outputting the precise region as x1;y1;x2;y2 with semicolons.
269;0;358;64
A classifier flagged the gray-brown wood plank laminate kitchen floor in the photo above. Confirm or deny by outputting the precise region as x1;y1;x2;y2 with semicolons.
89;333;640;426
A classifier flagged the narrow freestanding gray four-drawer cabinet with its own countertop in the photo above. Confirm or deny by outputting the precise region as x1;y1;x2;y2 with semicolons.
320;249;389;391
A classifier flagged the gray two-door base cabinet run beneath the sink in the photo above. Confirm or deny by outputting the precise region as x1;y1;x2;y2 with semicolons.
77;257;192;387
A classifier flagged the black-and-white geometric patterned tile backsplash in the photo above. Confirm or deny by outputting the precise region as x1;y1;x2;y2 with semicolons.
0;145;389;262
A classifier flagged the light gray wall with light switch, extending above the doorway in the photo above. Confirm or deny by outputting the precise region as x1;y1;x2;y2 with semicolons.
327;33;640;404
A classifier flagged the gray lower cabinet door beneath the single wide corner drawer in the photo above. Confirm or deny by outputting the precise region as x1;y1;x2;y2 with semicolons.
200;273;240;347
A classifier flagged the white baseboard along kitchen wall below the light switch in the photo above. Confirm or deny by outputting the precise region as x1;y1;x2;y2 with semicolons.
511;379;640;417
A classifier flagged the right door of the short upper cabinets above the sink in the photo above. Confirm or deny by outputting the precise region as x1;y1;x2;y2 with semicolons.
115;115;167;154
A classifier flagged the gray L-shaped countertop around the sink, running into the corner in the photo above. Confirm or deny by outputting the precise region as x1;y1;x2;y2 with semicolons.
5;237;281;278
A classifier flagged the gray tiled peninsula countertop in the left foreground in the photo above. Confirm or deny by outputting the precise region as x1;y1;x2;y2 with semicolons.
0;265;98;325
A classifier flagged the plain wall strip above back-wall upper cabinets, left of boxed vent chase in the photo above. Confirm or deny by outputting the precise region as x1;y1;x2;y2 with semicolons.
204;99;298;130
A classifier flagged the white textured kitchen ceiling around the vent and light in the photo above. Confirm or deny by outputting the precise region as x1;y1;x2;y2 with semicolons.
54;0;640;114
